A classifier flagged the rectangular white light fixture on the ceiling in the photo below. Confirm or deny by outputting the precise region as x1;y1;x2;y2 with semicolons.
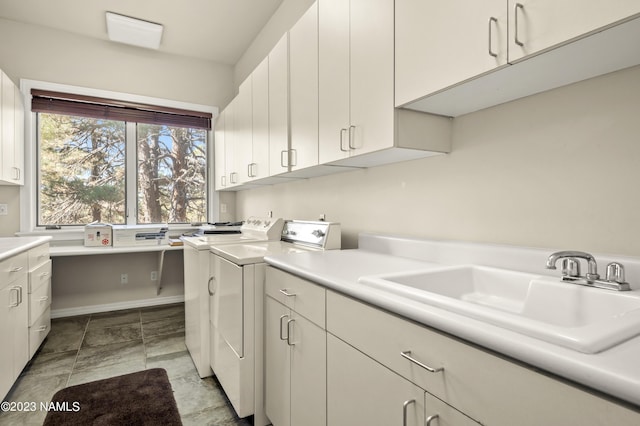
107;12;163;50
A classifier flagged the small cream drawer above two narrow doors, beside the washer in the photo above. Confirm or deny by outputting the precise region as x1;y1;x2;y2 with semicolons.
265;266;326;329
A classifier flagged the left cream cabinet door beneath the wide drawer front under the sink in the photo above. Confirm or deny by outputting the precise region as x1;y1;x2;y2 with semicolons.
327;334;424;426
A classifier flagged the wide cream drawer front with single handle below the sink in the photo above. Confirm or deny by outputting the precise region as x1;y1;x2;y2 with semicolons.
327;291;640;426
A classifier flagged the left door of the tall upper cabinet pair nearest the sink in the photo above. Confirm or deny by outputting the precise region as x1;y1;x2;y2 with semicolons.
318;0;350;164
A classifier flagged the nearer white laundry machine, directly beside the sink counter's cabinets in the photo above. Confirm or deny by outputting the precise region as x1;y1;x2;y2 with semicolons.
209;221;341;426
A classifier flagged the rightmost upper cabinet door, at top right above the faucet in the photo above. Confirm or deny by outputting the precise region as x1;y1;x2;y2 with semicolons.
509;0;640;62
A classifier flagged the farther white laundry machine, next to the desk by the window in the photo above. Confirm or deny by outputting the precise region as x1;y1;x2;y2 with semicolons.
182;217;284;377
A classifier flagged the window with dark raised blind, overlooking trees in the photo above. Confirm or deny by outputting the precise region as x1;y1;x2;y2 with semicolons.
32;90;211;226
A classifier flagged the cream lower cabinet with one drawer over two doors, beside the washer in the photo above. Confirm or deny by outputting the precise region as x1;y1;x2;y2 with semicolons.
265;268;327;426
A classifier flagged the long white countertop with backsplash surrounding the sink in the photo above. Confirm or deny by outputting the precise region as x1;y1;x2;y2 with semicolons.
265;236;640;406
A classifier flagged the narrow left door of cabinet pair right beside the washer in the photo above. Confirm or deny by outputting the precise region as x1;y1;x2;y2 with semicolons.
264;297;291;426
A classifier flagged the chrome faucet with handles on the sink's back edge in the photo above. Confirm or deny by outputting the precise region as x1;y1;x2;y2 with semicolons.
547;250;631;291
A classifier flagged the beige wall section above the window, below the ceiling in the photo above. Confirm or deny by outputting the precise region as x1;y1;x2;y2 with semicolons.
0;18;234;106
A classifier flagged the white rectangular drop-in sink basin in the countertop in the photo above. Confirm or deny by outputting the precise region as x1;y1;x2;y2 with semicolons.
359;266;640;353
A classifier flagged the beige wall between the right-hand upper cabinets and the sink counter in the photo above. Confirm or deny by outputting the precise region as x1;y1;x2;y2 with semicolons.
236;67;640;256
